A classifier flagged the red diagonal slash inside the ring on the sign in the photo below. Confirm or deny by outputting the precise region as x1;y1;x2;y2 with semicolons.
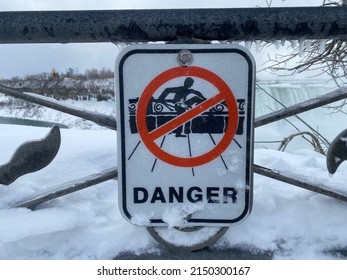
149;93;225;141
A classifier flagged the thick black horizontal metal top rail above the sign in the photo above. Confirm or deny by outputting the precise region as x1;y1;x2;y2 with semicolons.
0;7;347;43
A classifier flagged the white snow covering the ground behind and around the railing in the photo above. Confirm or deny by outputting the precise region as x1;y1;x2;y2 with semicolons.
0;86;347;259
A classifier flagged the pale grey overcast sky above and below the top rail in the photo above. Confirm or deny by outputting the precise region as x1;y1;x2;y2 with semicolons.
0;0;323;78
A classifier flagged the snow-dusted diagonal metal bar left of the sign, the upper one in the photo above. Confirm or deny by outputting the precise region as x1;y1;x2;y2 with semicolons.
0;85;117;130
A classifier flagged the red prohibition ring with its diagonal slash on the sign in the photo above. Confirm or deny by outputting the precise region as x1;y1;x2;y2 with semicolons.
136;66;238;167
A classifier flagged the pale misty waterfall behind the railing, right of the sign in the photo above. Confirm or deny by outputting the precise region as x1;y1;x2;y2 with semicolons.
255;79;347;151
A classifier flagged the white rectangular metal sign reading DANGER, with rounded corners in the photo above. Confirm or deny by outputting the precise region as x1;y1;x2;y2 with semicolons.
116;45;255;226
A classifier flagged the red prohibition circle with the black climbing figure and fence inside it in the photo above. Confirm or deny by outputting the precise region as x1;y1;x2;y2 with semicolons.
136;66;238;167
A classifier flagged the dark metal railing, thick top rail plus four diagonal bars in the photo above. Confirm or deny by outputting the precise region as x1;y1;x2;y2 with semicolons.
0;7;347;253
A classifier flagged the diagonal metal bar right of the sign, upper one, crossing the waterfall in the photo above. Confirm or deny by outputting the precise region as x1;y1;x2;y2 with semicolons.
254;87;347;127
